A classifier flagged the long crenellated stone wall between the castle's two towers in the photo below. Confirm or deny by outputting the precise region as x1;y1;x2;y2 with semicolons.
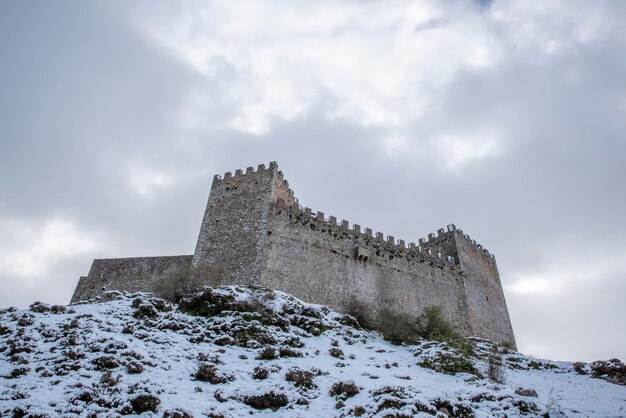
260;202;473;334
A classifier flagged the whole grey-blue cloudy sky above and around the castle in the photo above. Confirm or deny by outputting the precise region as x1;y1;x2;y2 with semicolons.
0;0;626;360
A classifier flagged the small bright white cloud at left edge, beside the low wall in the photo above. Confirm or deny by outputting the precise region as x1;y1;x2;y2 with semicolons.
0;217;102;280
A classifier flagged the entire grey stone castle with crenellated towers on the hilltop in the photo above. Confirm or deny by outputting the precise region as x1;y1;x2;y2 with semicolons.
71;162;515;346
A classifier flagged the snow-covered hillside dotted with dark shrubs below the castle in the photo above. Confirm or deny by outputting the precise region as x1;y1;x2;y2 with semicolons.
0;286;626;417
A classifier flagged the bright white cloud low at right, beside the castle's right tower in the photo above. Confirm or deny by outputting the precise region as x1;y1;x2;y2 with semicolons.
505;245;626;361
